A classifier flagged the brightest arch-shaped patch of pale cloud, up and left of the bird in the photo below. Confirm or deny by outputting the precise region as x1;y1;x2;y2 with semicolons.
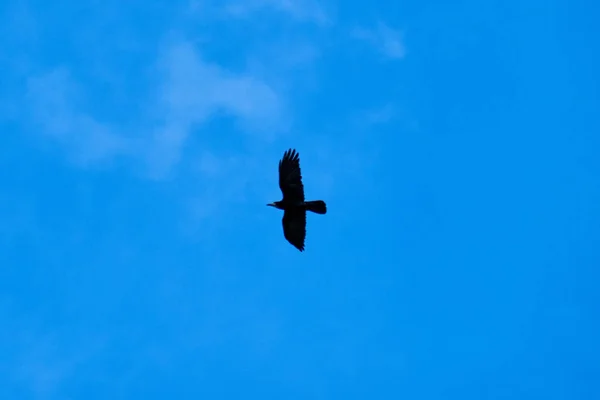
145;41;285;175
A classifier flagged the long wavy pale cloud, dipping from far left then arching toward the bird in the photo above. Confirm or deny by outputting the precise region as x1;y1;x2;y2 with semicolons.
26;40;287;178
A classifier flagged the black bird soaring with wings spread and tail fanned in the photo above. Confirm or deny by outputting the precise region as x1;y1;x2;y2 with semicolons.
267;149;327;252
